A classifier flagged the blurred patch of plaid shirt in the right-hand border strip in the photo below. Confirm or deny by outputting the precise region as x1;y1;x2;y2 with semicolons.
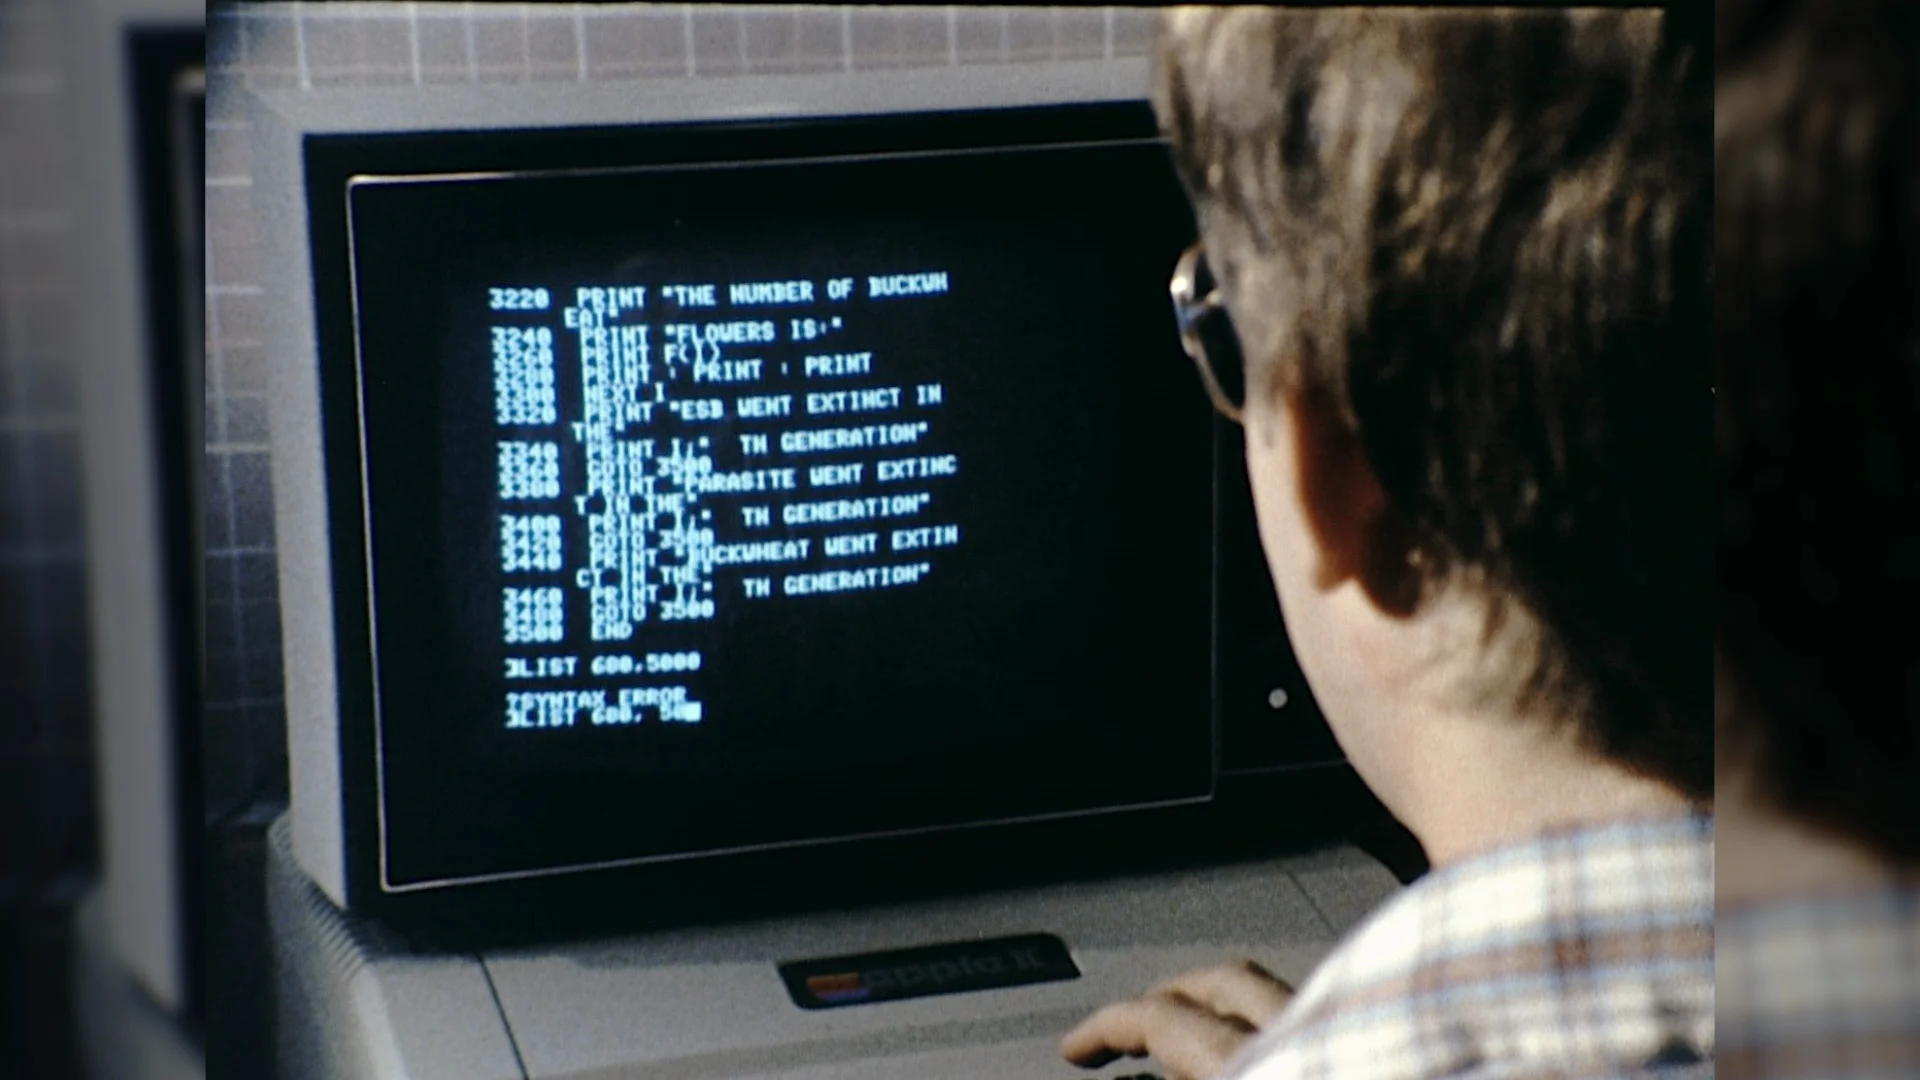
1718;884;1920;1080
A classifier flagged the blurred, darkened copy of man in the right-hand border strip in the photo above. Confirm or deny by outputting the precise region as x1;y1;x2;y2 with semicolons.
1715;0;1920;1080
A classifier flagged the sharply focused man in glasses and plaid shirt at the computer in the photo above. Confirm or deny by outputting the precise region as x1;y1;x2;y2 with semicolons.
1062;8;1715;1080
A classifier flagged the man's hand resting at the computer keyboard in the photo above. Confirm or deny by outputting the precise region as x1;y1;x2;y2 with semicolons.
1060;961;1294;1080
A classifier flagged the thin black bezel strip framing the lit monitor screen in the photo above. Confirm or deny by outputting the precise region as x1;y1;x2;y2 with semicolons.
305;102;1219;897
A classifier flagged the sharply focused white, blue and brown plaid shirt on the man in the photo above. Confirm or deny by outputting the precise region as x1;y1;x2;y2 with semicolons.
1227;817;1715;1080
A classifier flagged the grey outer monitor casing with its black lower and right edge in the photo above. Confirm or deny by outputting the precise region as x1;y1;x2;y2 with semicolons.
246;58;1344;933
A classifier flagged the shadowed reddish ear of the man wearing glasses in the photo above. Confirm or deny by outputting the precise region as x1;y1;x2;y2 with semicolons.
1281;390;1421;617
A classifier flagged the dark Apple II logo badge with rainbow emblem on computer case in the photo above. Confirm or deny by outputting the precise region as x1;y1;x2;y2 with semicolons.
780;934;1081;1009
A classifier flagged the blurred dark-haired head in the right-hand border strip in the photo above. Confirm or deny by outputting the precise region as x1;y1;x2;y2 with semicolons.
1715;0;1920;865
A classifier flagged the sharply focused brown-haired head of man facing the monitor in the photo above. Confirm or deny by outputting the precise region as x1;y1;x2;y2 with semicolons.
1154;8;1713;805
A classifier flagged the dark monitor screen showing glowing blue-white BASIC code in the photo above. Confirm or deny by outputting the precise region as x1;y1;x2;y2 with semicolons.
334;106;1215;892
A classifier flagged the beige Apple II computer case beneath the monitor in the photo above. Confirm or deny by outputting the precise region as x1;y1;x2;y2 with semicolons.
267;817;1400;1080
